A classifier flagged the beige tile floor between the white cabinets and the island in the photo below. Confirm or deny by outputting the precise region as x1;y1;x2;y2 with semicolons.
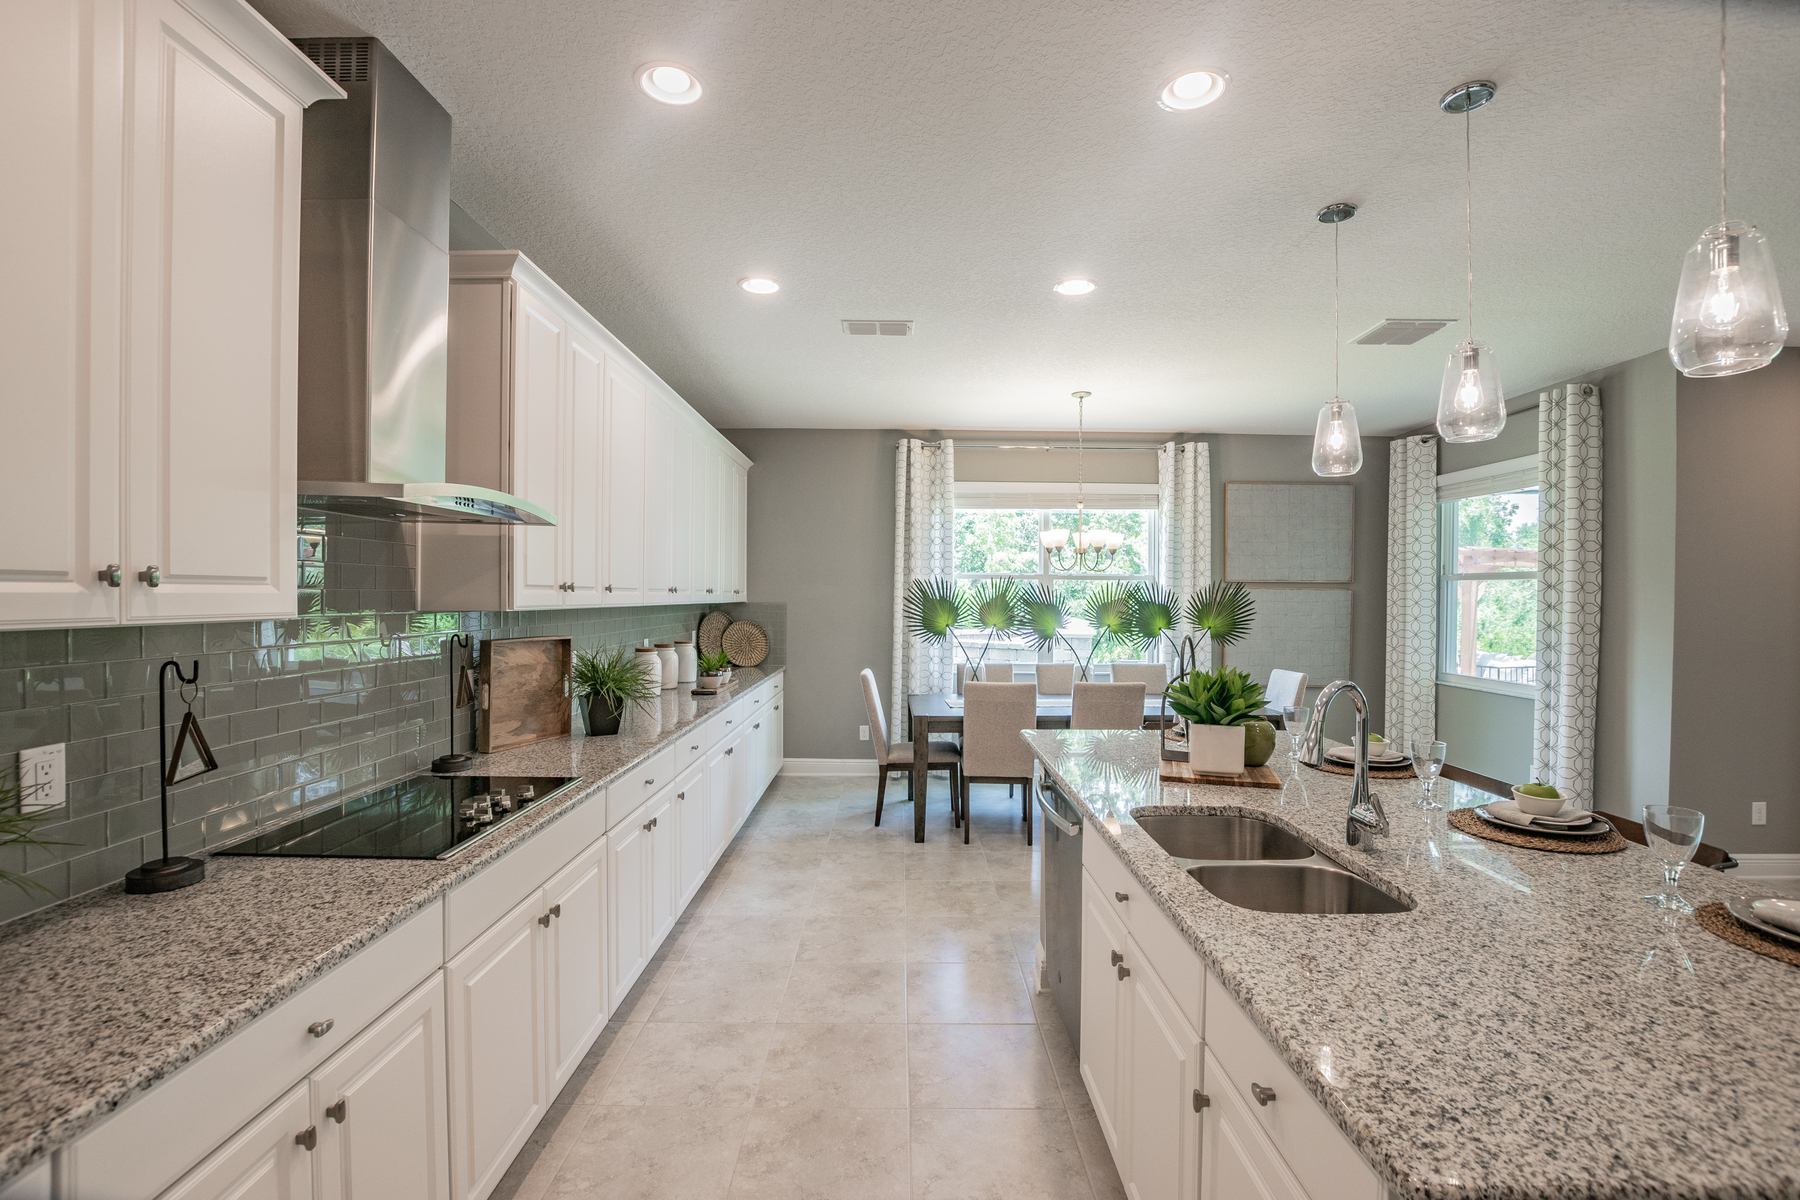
493;777;1123;1200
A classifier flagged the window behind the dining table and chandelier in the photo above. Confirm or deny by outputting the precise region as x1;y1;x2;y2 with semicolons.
956;502;1156;676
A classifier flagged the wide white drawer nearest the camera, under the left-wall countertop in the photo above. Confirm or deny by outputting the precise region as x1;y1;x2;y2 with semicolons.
63;903;445;1200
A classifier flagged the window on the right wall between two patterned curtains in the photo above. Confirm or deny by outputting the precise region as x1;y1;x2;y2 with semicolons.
1438;459;1537;696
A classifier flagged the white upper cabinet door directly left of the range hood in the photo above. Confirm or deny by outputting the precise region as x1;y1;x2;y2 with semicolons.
121;0;302;621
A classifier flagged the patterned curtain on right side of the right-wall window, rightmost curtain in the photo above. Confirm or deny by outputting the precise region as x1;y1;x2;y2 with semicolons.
1532;383;1600;808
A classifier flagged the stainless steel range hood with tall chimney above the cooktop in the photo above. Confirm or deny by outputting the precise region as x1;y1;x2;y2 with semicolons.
297;38;556;525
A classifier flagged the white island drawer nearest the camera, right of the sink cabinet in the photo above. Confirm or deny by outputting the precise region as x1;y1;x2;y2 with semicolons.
1206;972;1384;1200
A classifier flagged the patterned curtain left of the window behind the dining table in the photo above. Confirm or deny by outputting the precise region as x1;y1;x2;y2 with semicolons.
887;437;956;741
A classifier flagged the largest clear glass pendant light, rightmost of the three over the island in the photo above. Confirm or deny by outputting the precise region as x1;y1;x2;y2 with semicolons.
1669;0;1787;376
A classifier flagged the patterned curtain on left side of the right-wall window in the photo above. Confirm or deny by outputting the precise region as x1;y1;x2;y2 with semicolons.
1386;435;1438;750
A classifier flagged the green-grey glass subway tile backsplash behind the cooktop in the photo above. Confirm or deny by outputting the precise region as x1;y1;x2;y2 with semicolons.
0;518;770;919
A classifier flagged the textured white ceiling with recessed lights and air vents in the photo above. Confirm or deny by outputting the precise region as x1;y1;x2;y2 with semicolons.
252;0;1800;434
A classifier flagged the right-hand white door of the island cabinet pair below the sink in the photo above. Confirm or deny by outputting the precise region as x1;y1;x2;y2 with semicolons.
1123;964;1201;1200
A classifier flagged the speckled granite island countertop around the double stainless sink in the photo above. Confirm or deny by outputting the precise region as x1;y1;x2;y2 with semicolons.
1024;730;1800;1200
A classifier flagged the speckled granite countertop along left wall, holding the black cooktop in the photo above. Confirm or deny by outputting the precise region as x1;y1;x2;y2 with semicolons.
0;666;781;1184
